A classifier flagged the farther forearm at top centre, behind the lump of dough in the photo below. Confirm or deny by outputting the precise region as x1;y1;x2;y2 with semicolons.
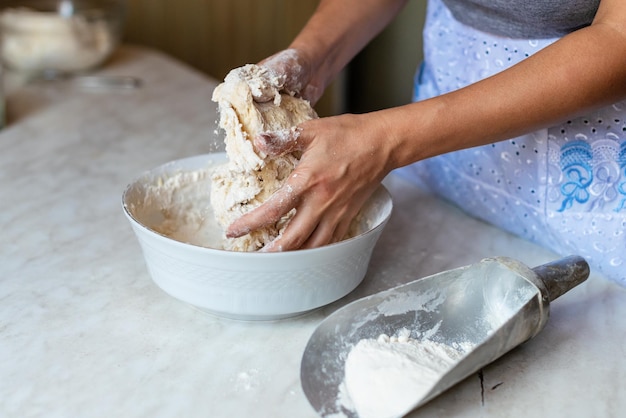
290;0;407;91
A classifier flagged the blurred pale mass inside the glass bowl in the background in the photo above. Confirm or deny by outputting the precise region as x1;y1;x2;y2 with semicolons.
0;8;117;72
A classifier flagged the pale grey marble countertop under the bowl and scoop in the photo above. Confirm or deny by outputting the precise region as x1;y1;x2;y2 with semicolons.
0;46;626;418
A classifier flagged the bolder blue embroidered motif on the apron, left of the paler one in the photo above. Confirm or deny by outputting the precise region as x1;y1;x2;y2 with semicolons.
559;141;593;212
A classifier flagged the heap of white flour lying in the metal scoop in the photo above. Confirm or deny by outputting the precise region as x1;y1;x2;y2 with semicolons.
343;328;466;418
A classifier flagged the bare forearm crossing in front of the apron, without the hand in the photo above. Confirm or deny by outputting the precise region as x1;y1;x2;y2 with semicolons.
379;3;626;168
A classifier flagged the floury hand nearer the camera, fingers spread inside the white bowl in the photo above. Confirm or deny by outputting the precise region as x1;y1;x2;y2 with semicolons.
227;113;390;251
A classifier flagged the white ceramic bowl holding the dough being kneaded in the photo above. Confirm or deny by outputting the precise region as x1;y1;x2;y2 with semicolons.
123;153;392;320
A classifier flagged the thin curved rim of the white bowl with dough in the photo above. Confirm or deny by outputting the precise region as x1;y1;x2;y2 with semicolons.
122;152;393;257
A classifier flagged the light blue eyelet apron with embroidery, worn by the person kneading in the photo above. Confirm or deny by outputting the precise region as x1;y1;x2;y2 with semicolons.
396;0;626;286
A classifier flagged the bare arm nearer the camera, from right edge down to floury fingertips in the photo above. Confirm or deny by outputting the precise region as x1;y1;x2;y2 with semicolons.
229;0;626;250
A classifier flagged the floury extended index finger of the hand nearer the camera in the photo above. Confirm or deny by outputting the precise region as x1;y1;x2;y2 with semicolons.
226;183;297;238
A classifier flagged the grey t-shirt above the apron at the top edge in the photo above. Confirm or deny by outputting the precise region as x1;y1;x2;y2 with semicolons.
443;0;600;39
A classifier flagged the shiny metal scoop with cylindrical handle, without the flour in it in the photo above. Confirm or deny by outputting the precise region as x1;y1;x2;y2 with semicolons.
300;256;589;418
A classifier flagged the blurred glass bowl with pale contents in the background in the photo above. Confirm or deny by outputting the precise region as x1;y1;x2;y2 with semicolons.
0;0;125;74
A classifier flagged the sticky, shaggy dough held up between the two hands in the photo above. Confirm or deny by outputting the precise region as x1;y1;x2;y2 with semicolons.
211;64;317;251
